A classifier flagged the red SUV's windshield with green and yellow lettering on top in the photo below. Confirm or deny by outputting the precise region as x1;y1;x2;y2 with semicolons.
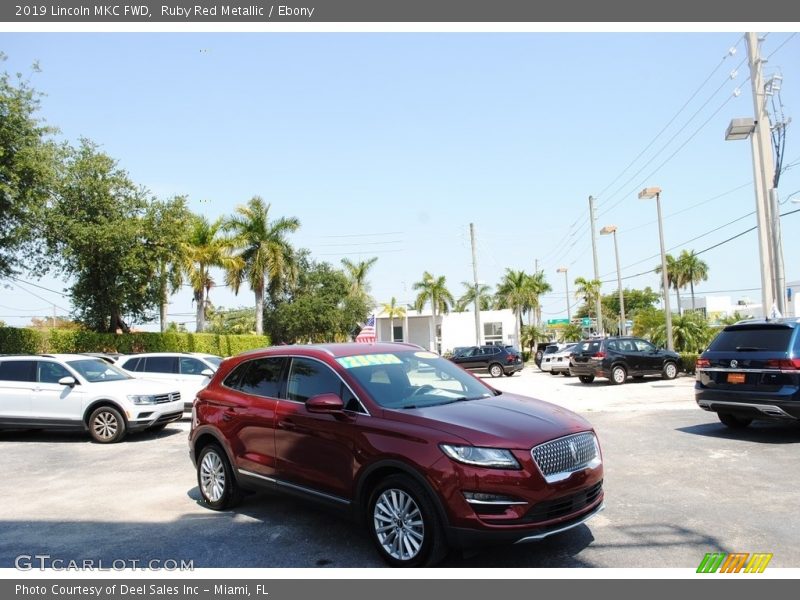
337;351;496;409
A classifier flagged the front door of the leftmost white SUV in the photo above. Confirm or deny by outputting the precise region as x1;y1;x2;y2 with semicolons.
31;360;85;427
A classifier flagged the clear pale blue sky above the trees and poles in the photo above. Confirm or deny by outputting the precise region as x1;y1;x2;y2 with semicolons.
0;32;800;329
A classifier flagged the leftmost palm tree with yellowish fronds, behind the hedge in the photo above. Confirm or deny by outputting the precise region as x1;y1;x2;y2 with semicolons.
183;216;241;333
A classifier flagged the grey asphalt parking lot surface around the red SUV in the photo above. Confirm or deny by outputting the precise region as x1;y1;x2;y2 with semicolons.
0;368;800;568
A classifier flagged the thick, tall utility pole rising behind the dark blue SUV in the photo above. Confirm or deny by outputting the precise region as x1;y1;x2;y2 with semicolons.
745;32;783;317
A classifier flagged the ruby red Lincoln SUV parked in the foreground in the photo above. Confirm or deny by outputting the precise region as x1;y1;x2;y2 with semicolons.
189;344;603;566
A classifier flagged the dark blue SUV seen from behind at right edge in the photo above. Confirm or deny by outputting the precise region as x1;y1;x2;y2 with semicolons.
694;318;800;428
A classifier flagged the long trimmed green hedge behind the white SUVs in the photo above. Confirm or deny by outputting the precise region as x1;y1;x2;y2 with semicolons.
0;327;269;356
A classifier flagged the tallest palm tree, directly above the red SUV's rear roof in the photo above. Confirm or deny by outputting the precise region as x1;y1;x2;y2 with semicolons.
225;196;300;335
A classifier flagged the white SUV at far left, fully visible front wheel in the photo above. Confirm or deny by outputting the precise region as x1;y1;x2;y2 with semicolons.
0;354;183;444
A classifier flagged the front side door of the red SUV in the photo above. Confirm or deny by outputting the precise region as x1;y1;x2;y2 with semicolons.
275;357;359;499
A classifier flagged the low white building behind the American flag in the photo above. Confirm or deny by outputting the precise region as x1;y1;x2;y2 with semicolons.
375;309;519;353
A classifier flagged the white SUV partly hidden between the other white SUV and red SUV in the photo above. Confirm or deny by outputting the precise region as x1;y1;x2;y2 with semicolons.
115;352;222;410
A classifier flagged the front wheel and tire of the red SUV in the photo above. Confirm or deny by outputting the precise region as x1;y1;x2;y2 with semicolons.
367;475;447;567
